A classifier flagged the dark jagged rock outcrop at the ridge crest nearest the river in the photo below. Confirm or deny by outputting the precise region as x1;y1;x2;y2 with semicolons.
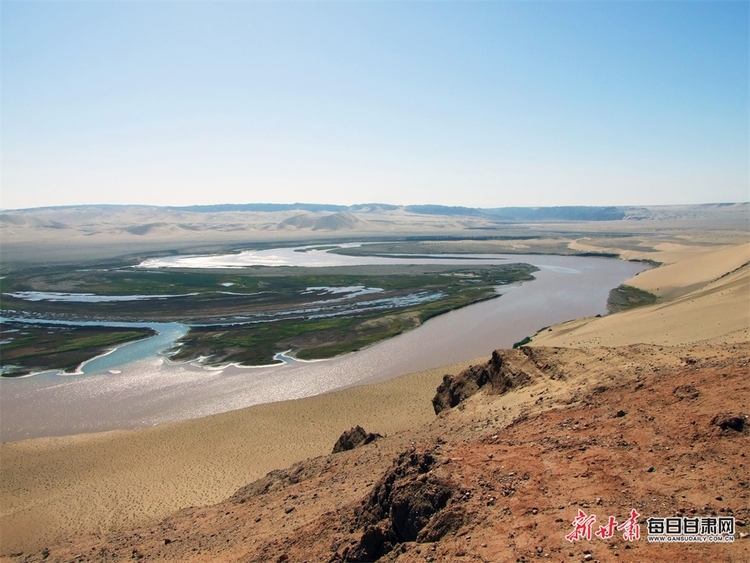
432;348;531;414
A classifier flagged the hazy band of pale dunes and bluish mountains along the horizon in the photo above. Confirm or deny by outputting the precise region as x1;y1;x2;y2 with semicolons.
0;203;750;265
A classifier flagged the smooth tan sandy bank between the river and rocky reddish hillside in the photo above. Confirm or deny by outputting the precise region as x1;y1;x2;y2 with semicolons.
0;362;482;554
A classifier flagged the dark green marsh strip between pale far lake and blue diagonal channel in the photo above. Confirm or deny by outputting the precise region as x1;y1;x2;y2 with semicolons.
0;263;535;324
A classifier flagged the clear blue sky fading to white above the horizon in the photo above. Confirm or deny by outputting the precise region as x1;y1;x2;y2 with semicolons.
0;0;750;209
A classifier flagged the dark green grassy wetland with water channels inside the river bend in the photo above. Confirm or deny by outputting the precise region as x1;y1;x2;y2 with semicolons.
0;256;536;369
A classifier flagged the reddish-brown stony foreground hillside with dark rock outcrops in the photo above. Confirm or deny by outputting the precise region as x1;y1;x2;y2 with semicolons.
9;344;750;563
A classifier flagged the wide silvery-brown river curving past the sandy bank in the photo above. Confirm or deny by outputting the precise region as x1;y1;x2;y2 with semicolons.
0;252;646;442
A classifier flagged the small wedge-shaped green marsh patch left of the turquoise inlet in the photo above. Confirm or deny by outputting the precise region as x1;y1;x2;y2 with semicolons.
0;322;156;377
